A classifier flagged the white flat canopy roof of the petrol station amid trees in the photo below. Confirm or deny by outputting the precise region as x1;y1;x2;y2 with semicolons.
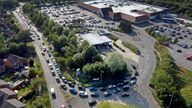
80;33;112;45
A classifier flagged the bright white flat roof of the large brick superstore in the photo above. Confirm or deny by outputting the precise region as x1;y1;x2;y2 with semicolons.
84;0;165;16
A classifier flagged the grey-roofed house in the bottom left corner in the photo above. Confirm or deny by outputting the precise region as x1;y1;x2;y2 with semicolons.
0;88;25;108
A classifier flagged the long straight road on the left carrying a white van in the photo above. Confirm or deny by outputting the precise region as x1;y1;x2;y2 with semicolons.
13;9;67;108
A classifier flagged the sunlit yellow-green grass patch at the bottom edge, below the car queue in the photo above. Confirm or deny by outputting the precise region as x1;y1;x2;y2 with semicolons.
96;101;133;108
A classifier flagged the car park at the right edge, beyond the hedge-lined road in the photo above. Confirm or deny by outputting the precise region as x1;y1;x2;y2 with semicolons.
152;23;192;70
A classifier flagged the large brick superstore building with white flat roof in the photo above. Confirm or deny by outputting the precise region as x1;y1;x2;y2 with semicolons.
78;0;167;24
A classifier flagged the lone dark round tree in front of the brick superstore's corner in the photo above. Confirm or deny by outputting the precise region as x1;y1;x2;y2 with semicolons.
119;21;132;33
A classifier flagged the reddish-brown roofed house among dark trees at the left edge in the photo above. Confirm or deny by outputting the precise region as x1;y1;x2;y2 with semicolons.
4;54;28;70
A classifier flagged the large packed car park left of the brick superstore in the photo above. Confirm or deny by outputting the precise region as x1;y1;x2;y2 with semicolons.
41;5;119;29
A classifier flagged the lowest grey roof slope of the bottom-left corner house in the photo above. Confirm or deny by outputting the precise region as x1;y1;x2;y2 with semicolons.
6;99;25;108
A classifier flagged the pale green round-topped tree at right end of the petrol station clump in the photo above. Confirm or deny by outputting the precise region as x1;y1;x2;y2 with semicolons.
105;53;130;76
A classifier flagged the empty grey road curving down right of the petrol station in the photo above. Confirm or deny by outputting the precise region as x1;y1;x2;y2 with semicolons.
112;27;160;108
